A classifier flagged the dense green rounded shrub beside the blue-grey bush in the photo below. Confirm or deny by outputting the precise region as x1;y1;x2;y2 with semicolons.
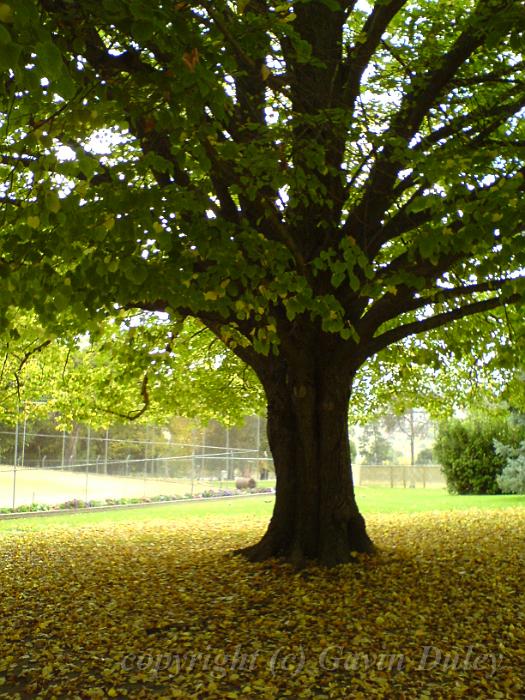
434;417;519;494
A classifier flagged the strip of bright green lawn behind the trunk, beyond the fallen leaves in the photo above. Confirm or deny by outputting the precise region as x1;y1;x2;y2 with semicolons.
0;486;525;532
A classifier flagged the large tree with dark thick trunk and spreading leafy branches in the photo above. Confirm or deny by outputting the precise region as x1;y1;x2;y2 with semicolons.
0;0;525;564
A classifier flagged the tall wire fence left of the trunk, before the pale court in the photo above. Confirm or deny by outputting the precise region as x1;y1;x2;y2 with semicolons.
0;424;273;508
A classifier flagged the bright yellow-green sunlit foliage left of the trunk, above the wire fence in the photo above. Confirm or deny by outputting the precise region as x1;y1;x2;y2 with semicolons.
0;311;263;428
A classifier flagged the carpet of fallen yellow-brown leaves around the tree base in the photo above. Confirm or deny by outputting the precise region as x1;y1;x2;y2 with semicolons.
0;508;525;700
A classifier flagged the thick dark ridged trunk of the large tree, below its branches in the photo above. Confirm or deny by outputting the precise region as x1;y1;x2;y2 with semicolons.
235;355;374;566
